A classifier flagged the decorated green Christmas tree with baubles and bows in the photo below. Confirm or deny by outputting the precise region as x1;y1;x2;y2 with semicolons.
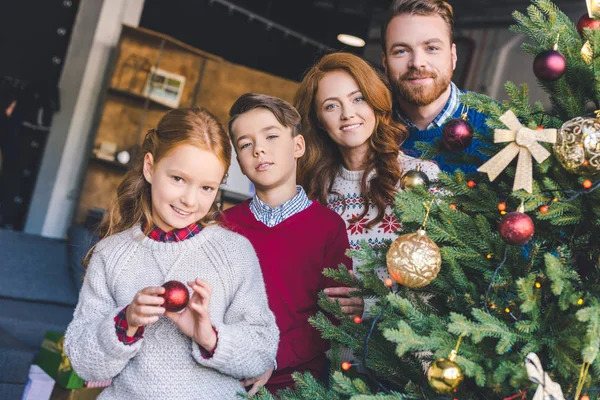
246;0;600;400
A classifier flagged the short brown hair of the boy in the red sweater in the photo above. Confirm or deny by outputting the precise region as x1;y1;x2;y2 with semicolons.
229;93;301;141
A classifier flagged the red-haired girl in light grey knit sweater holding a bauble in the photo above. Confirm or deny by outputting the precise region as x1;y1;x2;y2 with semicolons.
65;109;279;399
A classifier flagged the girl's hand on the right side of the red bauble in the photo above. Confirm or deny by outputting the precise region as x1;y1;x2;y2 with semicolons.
165;279;217;352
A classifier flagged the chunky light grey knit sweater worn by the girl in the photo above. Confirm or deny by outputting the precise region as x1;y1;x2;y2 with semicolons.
65;225;279;400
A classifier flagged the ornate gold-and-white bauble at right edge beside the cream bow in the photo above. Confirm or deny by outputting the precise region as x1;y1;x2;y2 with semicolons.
553;117;600;175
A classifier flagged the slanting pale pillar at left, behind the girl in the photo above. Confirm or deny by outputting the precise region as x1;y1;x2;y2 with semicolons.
25;0;144;238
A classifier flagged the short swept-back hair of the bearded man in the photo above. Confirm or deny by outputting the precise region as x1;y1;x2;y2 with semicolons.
381;0;454;53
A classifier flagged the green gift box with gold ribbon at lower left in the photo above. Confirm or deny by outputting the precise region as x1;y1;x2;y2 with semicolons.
37;331;85;389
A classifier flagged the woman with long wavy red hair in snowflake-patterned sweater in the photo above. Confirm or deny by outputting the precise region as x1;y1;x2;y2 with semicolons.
295;53;439;316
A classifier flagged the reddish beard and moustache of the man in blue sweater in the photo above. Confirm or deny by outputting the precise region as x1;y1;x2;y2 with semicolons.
390;69;453;107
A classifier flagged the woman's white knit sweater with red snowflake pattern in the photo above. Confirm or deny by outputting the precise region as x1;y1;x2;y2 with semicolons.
327;153;440;280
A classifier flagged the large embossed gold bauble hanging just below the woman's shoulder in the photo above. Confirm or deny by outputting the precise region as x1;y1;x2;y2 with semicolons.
387;229;442;288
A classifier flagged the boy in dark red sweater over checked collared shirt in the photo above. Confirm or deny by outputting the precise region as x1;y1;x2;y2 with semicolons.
223;93;352;394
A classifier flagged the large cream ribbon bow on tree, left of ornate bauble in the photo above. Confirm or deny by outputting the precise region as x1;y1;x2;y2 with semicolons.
477;110;556;193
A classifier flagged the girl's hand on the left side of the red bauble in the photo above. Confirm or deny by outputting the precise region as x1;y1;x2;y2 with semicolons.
125;286;165;336
